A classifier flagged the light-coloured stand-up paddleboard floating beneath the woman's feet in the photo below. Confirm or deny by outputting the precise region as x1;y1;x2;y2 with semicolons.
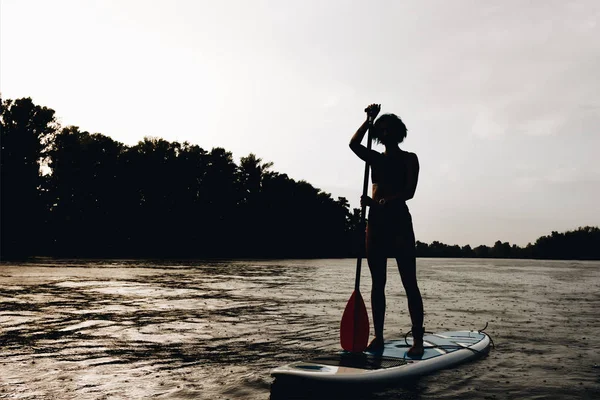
271;331;491;383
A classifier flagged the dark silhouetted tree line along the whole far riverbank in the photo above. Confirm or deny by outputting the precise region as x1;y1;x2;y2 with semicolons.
0;98;600;259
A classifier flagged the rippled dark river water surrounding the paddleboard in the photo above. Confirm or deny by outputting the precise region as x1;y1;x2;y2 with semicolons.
0;259;600;400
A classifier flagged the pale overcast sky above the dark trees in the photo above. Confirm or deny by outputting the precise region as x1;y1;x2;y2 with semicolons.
0;0;600;245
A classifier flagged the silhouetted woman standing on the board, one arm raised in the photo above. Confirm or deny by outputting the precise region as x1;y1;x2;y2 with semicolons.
350;104;424;357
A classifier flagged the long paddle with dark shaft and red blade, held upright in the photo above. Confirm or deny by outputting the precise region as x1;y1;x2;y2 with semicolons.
340;110;373;353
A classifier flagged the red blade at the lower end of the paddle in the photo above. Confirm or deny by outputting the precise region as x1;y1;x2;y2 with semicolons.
340;291;369;352
